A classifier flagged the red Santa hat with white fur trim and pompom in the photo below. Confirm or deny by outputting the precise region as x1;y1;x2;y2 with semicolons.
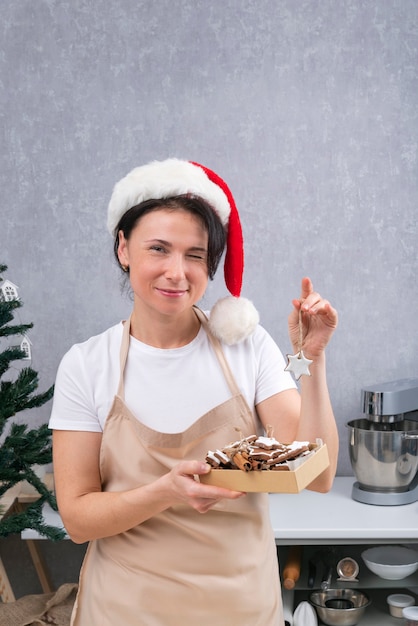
107;159;259;345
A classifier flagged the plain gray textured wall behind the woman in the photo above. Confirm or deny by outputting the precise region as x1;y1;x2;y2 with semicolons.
0;0;418;474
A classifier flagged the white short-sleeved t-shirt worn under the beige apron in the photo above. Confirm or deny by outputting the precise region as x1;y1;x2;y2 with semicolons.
49;323;296;433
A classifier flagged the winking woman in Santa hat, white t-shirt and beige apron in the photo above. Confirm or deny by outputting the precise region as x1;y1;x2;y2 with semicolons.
50;159;338;626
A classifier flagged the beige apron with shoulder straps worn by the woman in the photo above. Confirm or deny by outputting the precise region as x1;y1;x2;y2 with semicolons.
71;310;284;626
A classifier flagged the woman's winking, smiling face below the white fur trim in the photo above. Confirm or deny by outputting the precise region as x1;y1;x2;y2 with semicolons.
118;208;208;314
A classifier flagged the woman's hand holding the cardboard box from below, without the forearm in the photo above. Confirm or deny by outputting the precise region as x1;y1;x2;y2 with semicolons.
160;461;245;513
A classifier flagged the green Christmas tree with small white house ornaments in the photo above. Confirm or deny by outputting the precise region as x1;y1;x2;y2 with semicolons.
0;265;65;540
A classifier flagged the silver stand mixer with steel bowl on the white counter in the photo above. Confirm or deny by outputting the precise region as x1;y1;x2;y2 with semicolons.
347;378;418;506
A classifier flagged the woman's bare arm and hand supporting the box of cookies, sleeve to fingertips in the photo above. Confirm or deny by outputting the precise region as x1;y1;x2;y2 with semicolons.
53;430;247;543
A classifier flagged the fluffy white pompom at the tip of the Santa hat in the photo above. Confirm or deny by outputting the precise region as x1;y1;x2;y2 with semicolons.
209;296;260;346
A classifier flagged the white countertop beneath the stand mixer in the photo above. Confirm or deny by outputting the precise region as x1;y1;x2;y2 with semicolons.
270;477;418;545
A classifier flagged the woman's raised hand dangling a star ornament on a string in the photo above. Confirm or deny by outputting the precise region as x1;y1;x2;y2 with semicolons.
288;278;338;359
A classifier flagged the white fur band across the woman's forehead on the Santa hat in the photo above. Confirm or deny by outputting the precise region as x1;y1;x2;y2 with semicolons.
107;159;231;235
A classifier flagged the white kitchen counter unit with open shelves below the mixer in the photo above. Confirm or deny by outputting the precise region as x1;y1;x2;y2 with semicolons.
269;477;418;626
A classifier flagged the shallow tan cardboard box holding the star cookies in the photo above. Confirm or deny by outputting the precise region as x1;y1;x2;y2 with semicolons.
199;444;329;493
